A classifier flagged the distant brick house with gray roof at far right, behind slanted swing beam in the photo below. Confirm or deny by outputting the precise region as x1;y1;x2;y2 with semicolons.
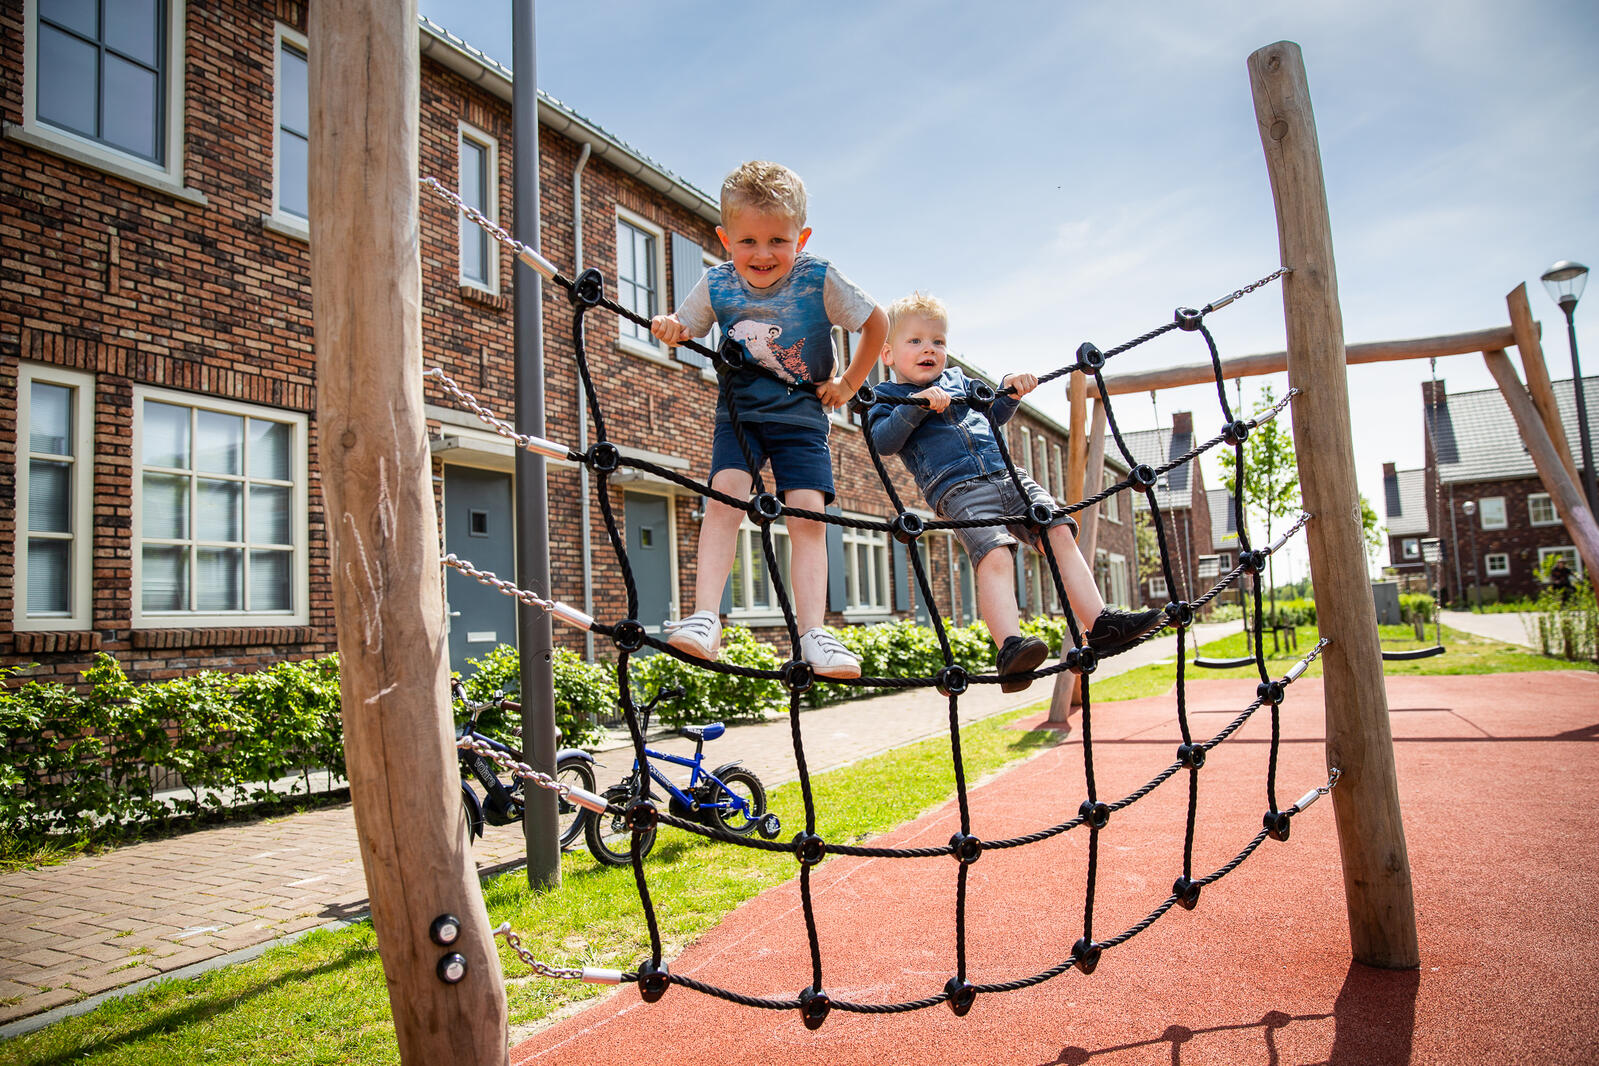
1422;377;1599;604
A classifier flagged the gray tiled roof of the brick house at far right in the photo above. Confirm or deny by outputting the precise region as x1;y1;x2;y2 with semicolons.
1422;377;1599;484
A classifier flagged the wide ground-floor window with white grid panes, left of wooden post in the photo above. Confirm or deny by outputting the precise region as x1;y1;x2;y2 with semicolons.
133;390;307;626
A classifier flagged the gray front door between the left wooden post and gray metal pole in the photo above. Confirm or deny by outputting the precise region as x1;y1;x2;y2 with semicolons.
445;467;516;676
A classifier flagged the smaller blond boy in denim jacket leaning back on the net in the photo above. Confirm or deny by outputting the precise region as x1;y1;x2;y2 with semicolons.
867;292;1164;692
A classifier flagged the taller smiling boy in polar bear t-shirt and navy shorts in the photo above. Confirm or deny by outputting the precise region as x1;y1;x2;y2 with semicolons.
649;161;887;678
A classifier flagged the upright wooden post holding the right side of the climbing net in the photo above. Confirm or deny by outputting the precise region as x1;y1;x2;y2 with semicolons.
1249;42;1420;969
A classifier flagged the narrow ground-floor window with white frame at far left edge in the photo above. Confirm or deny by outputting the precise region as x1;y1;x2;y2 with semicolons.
13;363;94;630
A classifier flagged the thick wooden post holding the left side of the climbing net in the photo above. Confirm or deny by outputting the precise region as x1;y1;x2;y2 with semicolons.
309;0;508;1063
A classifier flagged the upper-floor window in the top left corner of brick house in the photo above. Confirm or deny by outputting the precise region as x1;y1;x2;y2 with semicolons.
17;0;191;194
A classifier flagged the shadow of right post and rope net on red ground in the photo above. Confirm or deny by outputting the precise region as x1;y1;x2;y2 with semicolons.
1038;962;1422;1066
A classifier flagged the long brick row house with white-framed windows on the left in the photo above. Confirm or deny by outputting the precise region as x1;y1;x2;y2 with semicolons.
0;0;1112;681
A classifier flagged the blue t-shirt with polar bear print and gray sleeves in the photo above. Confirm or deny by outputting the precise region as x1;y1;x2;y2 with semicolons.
676;253;876;430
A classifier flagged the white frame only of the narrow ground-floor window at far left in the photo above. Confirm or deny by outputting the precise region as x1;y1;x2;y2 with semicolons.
11;363;94;633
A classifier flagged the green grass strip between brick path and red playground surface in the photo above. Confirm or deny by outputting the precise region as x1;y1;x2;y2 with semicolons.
0;626;1573;1066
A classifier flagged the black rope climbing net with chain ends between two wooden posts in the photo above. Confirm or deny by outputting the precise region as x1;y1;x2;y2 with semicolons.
422;177;1338;1029
